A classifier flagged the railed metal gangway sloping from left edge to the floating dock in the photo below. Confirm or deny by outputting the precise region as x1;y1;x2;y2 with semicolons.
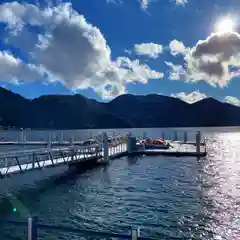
0;143;126;178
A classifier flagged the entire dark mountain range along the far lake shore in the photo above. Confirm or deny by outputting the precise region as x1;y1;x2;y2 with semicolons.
0;88;240;129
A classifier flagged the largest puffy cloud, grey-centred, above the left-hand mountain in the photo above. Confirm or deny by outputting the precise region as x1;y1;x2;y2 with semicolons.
0;2;163;97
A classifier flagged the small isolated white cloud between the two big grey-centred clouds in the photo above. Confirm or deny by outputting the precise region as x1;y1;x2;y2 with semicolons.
134;43;163;58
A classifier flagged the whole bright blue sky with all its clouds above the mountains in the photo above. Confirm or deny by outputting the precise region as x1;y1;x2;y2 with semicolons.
0;0;240;105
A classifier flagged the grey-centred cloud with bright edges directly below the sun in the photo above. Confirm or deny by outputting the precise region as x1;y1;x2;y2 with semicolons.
167;32;240;87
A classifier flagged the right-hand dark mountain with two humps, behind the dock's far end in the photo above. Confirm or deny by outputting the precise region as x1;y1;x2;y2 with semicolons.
107;94;240;127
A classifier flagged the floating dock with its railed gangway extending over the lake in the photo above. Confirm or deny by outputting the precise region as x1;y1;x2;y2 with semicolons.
0;132;207;178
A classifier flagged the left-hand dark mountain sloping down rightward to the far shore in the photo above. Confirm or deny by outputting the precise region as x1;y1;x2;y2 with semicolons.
0;88;131;129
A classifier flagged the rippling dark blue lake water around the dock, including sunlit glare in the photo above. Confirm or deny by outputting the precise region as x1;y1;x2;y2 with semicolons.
0;128;240;240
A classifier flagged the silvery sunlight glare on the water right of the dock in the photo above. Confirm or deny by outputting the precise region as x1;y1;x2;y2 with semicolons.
202;133;240;239
